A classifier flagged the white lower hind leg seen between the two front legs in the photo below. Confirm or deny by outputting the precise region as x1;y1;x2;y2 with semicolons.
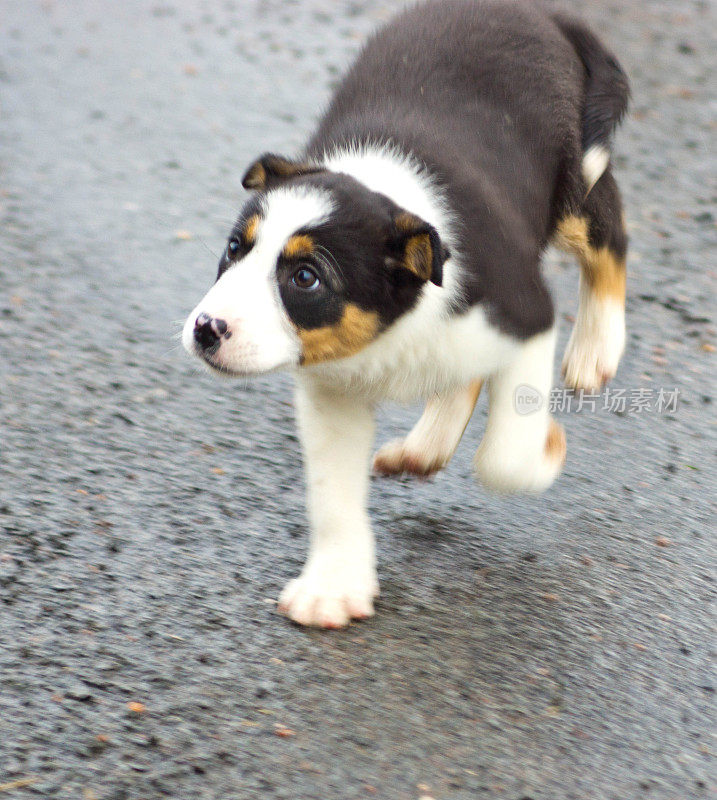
373;380;482;476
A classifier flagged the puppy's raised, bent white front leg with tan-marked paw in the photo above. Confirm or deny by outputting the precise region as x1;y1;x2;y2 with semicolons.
474;330;565;492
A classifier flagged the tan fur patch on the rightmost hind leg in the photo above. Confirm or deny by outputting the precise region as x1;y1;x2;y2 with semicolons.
555;217;625;303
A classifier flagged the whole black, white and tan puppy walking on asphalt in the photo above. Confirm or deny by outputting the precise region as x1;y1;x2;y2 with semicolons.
184;0;628;627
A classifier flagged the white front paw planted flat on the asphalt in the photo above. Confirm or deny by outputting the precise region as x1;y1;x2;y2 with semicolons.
279;561;378;628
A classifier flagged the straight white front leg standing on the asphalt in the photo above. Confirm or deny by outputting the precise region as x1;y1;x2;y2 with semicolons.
279;382;378;628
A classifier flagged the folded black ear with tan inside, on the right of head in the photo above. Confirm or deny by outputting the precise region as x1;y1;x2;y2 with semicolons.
389;211;450;286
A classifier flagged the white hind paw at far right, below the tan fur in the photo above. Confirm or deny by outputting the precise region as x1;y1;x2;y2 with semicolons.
562;300;625;391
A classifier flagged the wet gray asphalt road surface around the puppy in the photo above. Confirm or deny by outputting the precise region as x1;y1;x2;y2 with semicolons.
0;0;717;800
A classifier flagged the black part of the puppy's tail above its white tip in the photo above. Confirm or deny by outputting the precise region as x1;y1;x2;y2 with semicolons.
553;13;630;152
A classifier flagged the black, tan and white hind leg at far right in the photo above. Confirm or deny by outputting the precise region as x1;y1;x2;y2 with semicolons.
555;170;627;390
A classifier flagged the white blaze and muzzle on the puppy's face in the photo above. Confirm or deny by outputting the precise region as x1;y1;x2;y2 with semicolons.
183;187;332;373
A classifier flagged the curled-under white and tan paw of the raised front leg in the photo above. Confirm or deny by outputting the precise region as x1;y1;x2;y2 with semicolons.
473;420;566;494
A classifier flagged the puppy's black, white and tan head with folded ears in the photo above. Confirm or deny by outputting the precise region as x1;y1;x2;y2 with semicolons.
183;155;448;375
